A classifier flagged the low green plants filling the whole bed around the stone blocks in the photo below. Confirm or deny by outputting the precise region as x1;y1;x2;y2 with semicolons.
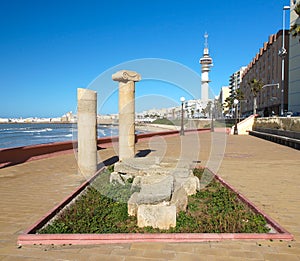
38;169;269;234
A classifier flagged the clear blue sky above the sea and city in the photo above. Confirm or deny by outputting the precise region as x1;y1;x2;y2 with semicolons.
0;0;289;117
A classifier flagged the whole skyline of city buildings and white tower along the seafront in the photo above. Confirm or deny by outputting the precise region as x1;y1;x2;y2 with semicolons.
0;0;300;123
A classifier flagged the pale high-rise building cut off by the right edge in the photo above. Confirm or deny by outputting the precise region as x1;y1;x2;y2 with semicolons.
288;0;300;113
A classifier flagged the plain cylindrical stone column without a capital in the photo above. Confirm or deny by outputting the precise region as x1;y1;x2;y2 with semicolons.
77;88;97;176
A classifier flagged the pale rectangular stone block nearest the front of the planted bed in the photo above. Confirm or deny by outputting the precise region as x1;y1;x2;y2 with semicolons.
137;205;176;229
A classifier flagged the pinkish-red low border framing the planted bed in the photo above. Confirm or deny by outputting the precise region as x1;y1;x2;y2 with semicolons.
17;168;294;245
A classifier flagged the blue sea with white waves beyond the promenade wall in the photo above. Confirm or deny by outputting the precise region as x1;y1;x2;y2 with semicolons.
0;123;118;149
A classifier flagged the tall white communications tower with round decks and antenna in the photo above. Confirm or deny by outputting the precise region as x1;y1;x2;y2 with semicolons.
199;33;213;101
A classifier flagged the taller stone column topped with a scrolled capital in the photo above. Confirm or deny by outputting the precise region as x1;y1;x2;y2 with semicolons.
112;70;141;161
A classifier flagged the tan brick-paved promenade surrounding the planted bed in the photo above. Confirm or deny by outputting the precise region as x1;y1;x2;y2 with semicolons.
0;133;300;261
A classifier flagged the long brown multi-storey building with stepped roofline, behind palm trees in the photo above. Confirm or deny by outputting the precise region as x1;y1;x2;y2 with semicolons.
240;30;289;116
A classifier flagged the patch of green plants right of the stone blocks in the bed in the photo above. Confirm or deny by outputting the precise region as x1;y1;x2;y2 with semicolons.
176;169;269;233
